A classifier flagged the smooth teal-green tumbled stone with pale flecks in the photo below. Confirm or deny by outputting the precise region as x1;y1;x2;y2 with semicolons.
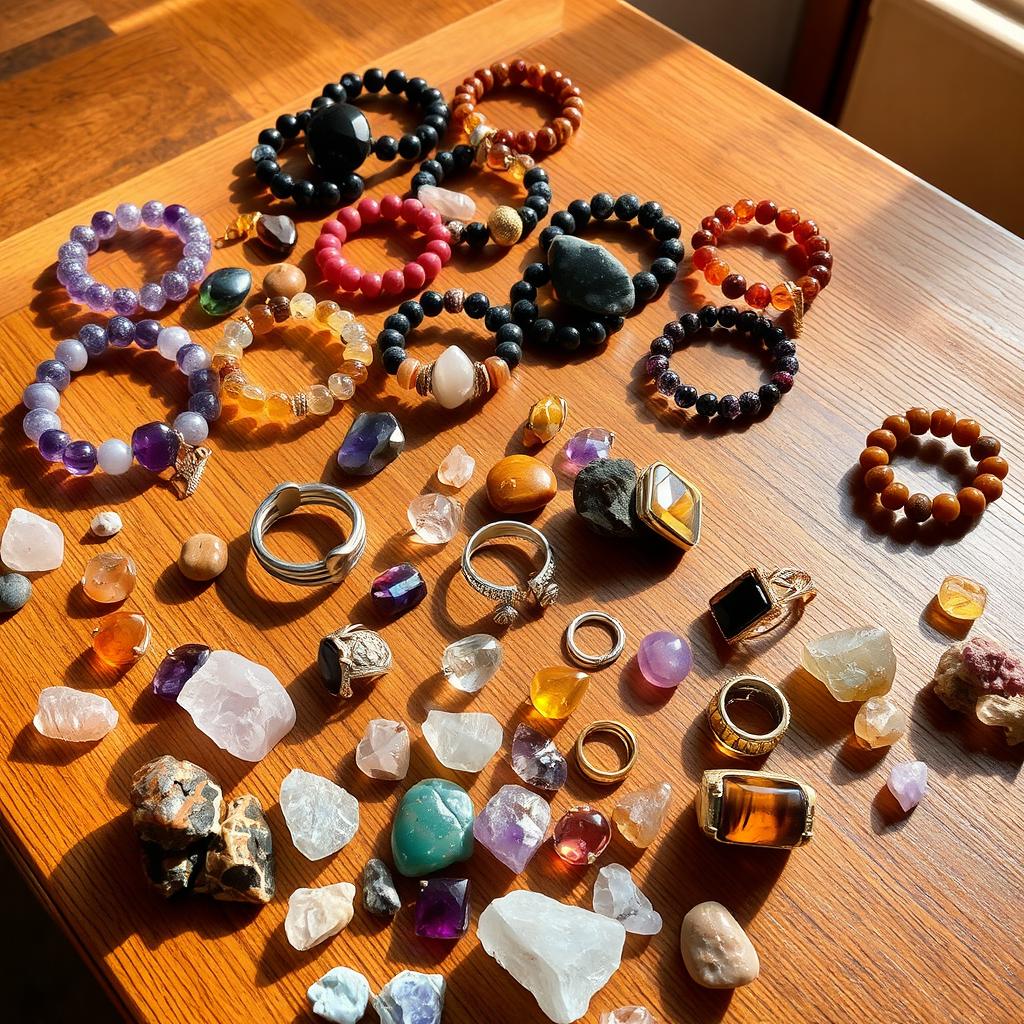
391;778;474;878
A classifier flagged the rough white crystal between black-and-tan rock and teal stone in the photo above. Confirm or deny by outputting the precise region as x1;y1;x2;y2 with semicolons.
280;768;359;860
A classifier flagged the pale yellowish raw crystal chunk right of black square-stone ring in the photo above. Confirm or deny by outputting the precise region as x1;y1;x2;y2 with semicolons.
801;626;896;700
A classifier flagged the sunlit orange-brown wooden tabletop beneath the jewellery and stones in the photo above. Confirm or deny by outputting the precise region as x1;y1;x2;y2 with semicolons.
0;0;1024;1024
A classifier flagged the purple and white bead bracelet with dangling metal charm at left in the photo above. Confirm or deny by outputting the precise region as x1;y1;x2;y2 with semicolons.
22;316;220;498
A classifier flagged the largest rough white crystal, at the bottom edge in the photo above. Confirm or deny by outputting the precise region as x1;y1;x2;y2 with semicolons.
477;889;626;1024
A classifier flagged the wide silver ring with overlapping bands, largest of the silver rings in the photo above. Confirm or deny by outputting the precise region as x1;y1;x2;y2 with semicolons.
249;483;367;587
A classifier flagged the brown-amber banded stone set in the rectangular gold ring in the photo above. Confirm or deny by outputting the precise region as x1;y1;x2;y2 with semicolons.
718;775;807;848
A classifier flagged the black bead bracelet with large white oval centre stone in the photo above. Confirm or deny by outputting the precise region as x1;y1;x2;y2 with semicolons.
377;288;522;409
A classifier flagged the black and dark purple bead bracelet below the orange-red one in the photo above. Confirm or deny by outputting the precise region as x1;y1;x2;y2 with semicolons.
645;305;800;420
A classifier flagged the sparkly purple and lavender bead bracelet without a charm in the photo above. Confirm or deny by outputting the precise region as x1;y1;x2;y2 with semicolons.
57;200;213;316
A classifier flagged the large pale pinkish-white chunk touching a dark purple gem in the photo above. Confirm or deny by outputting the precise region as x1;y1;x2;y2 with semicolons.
178;650;295;761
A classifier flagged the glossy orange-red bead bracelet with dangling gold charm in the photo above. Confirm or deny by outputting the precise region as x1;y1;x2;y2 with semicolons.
690;199;833;323
